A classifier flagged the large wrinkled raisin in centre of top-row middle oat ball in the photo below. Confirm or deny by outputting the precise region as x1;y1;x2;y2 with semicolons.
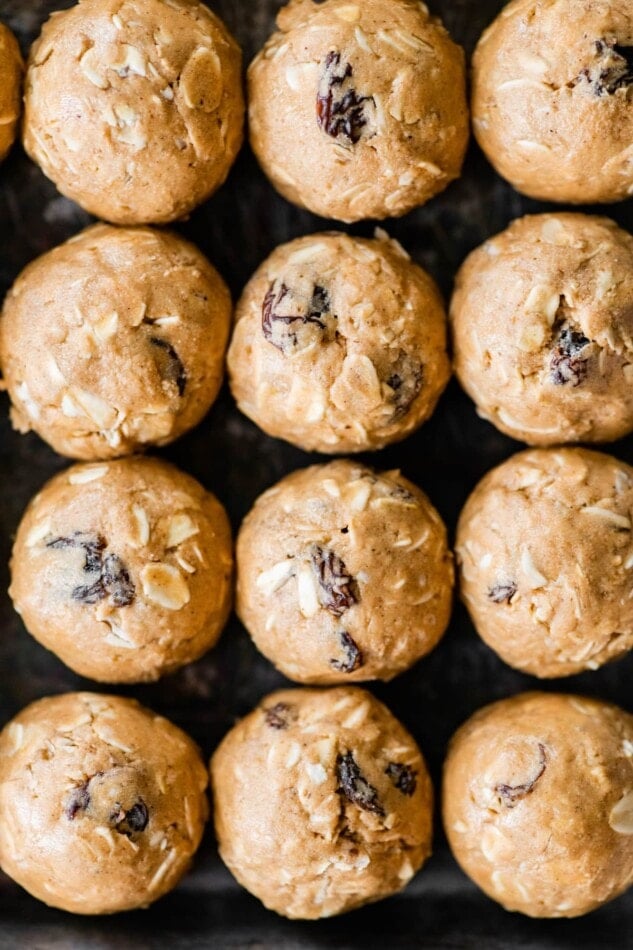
316;50;374;145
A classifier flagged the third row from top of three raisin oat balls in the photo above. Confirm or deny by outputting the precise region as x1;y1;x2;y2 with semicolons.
9;448;633;684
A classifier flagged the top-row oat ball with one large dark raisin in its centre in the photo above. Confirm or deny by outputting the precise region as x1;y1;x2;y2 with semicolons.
248;0;468;221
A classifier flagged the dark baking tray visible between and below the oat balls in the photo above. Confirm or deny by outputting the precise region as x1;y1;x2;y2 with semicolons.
0;0;633;950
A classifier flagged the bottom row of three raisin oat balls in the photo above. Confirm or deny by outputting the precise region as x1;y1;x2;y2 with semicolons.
0;686;633;919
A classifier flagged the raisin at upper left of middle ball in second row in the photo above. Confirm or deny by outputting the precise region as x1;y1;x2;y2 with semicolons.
262;281;338;354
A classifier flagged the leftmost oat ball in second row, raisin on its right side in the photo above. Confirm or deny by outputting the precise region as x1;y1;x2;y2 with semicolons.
0;224;231;461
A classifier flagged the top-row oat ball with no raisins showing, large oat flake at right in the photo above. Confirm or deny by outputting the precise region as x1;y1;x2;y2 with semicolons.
24;0;244;224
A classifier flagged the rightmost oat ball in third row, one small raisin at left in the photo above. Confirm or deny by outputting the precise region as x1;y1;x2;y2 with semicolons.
456;448;633;677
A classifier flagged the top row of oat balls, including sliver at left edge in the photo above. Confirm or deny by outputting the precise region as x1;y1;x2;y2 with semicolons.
0;0;633;224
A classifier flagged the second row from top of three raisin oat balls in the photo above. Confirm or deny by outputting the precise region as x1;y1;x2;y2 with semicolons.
0;213;633;460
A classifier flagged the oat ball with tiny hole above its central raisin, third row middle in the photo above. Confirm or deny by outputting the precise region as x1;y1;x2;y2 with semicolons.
237;461;453;684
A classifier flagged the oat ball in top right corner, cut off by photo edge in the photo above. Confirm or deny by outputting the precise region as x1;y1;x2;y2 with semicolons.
472;0;633;204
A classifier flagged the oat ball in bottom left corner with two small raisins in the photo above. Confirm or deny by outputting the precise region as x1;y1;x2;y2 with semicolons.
0;693;208;914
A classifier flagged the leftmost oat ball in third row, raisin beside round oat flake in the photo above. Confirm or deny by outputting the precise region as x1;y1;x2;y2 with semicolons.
9;458;233;683
